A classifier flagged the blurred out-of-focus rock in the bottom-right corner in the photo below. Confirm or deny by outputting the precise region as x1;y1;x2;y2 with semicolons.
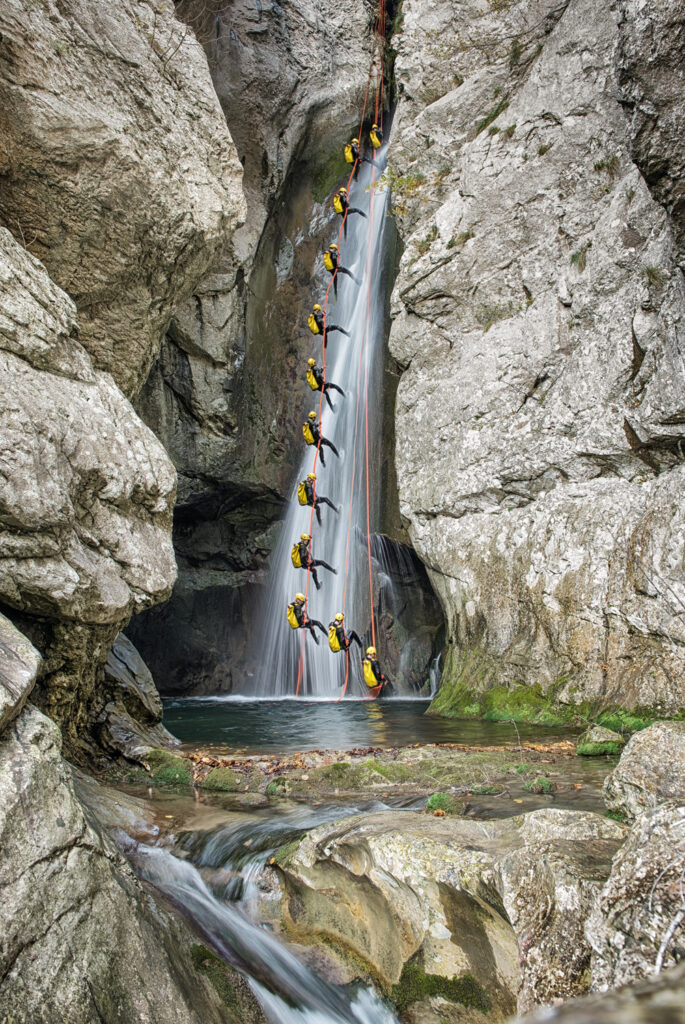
517;967;685;1024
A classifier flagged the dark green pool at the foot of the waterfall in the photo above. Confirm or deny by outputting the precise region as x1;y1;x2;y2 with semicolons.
164;697;568;754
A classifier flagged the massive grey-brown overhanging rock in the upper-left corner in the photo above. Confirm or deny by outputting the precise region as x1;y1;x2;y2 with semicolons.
0;0;245;395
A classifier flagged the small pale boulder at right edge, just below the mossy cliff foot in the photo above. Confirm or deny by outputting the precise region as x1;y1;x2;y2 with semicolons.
604;722;685;818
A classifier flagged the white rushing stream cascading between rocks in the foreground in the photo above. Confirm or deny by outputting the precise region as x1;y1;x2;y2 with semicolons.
129;803;396;1024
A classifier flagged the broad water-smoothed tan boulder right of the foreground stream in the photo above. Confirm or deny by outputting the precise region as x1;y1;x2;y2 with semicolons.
279;809;627;1013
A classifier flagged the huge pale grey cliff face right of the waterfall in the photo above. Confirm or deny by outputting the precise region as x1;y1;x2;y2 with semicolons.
390;0;685;714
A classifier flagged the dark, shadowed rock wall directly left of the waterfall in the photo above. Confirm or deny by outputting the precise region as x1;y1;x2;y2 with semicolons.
130;0;382;692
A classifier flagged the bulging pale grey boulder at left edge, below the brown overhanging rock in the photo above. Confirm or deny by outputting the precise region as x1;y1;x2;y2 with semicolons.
0;228;176;625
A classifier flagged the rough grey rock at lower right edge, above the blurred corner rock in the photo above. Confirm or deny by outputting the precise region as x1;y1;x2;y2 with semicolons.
586;801;685;991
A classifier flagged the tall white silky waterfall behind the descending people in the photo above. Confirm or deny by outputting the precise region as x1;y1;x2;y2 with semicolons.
246;150;389;697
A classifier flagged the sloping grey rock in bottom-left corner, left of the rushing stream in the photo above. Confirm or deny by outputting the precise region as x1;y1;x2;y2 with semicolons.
0;707;239;1024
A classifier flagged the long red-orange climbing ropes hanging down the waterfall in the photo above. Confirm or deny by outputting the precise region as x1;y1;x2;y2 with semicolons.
295;0;385;702
